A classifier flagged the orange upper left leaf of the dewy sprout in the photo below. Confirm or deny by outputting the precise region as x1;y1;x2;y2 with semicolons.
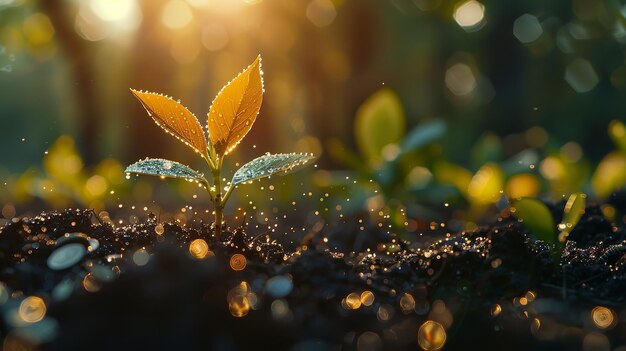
130;89;206;155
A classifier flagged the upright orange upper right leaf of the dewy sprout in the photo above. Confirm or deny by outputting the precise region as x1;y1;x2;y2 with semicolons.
208;55;263;156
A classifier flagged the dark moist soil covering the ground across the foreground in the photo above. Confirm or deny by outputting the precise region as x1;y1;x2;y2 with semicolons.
0;194;626;351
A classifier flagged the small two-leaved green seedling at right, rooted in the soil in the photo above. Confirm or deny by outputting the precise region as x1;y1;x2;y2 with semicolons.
511;193;587;263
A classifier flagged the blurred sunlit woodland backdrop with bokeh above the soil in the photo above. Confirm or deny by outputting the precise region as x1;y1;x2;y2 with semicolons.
0;0;626;228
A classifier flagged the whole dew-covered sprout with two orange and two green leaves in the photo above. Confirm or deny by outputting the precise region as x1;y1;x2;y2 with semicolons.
126;55;314;240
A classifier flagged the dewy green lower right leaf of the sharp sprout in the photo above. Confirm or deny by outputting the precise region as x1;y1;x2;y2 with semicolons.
231;153;315;186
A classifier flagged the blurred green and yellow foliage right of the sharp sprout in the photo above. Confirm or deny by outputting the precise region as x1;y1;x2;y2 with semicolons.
320;88;626;231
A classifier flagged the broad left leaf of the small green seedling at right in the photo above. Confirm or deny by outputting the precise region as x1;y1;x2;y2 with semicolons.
511;197;554;246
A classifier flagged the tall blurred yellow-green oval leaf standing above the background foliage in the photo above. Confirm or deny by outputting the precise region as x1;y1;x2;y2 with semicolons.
354;88;406;165
